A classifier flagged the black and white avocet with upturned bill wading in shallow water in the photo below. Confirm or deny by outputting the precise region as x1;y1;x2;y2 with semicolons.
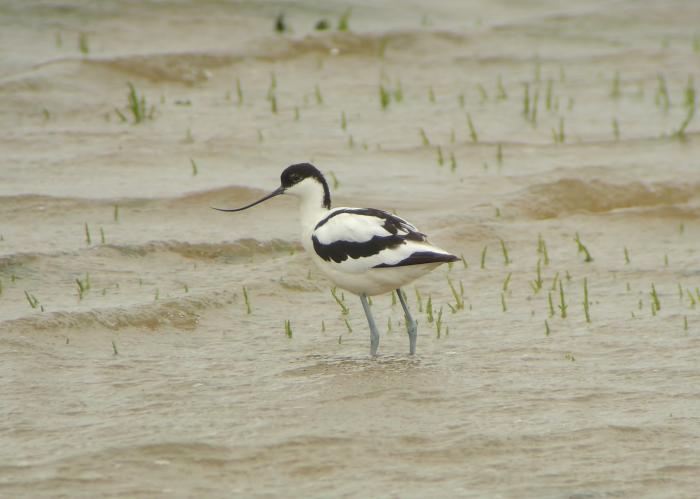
219;163;458;356
